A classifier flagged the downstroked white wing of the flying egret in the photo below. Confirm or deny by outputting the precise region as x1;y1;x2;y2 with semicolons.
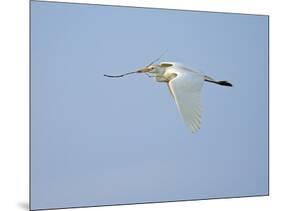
168;72;204;133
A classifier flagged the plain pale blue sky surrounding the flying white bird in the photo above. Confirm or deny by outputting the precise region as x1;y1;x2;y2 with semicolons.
31;2;268;209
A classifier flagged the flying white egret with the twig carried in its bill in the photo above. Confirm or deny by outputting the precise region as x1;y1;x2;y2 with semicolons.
105;62;232;133
